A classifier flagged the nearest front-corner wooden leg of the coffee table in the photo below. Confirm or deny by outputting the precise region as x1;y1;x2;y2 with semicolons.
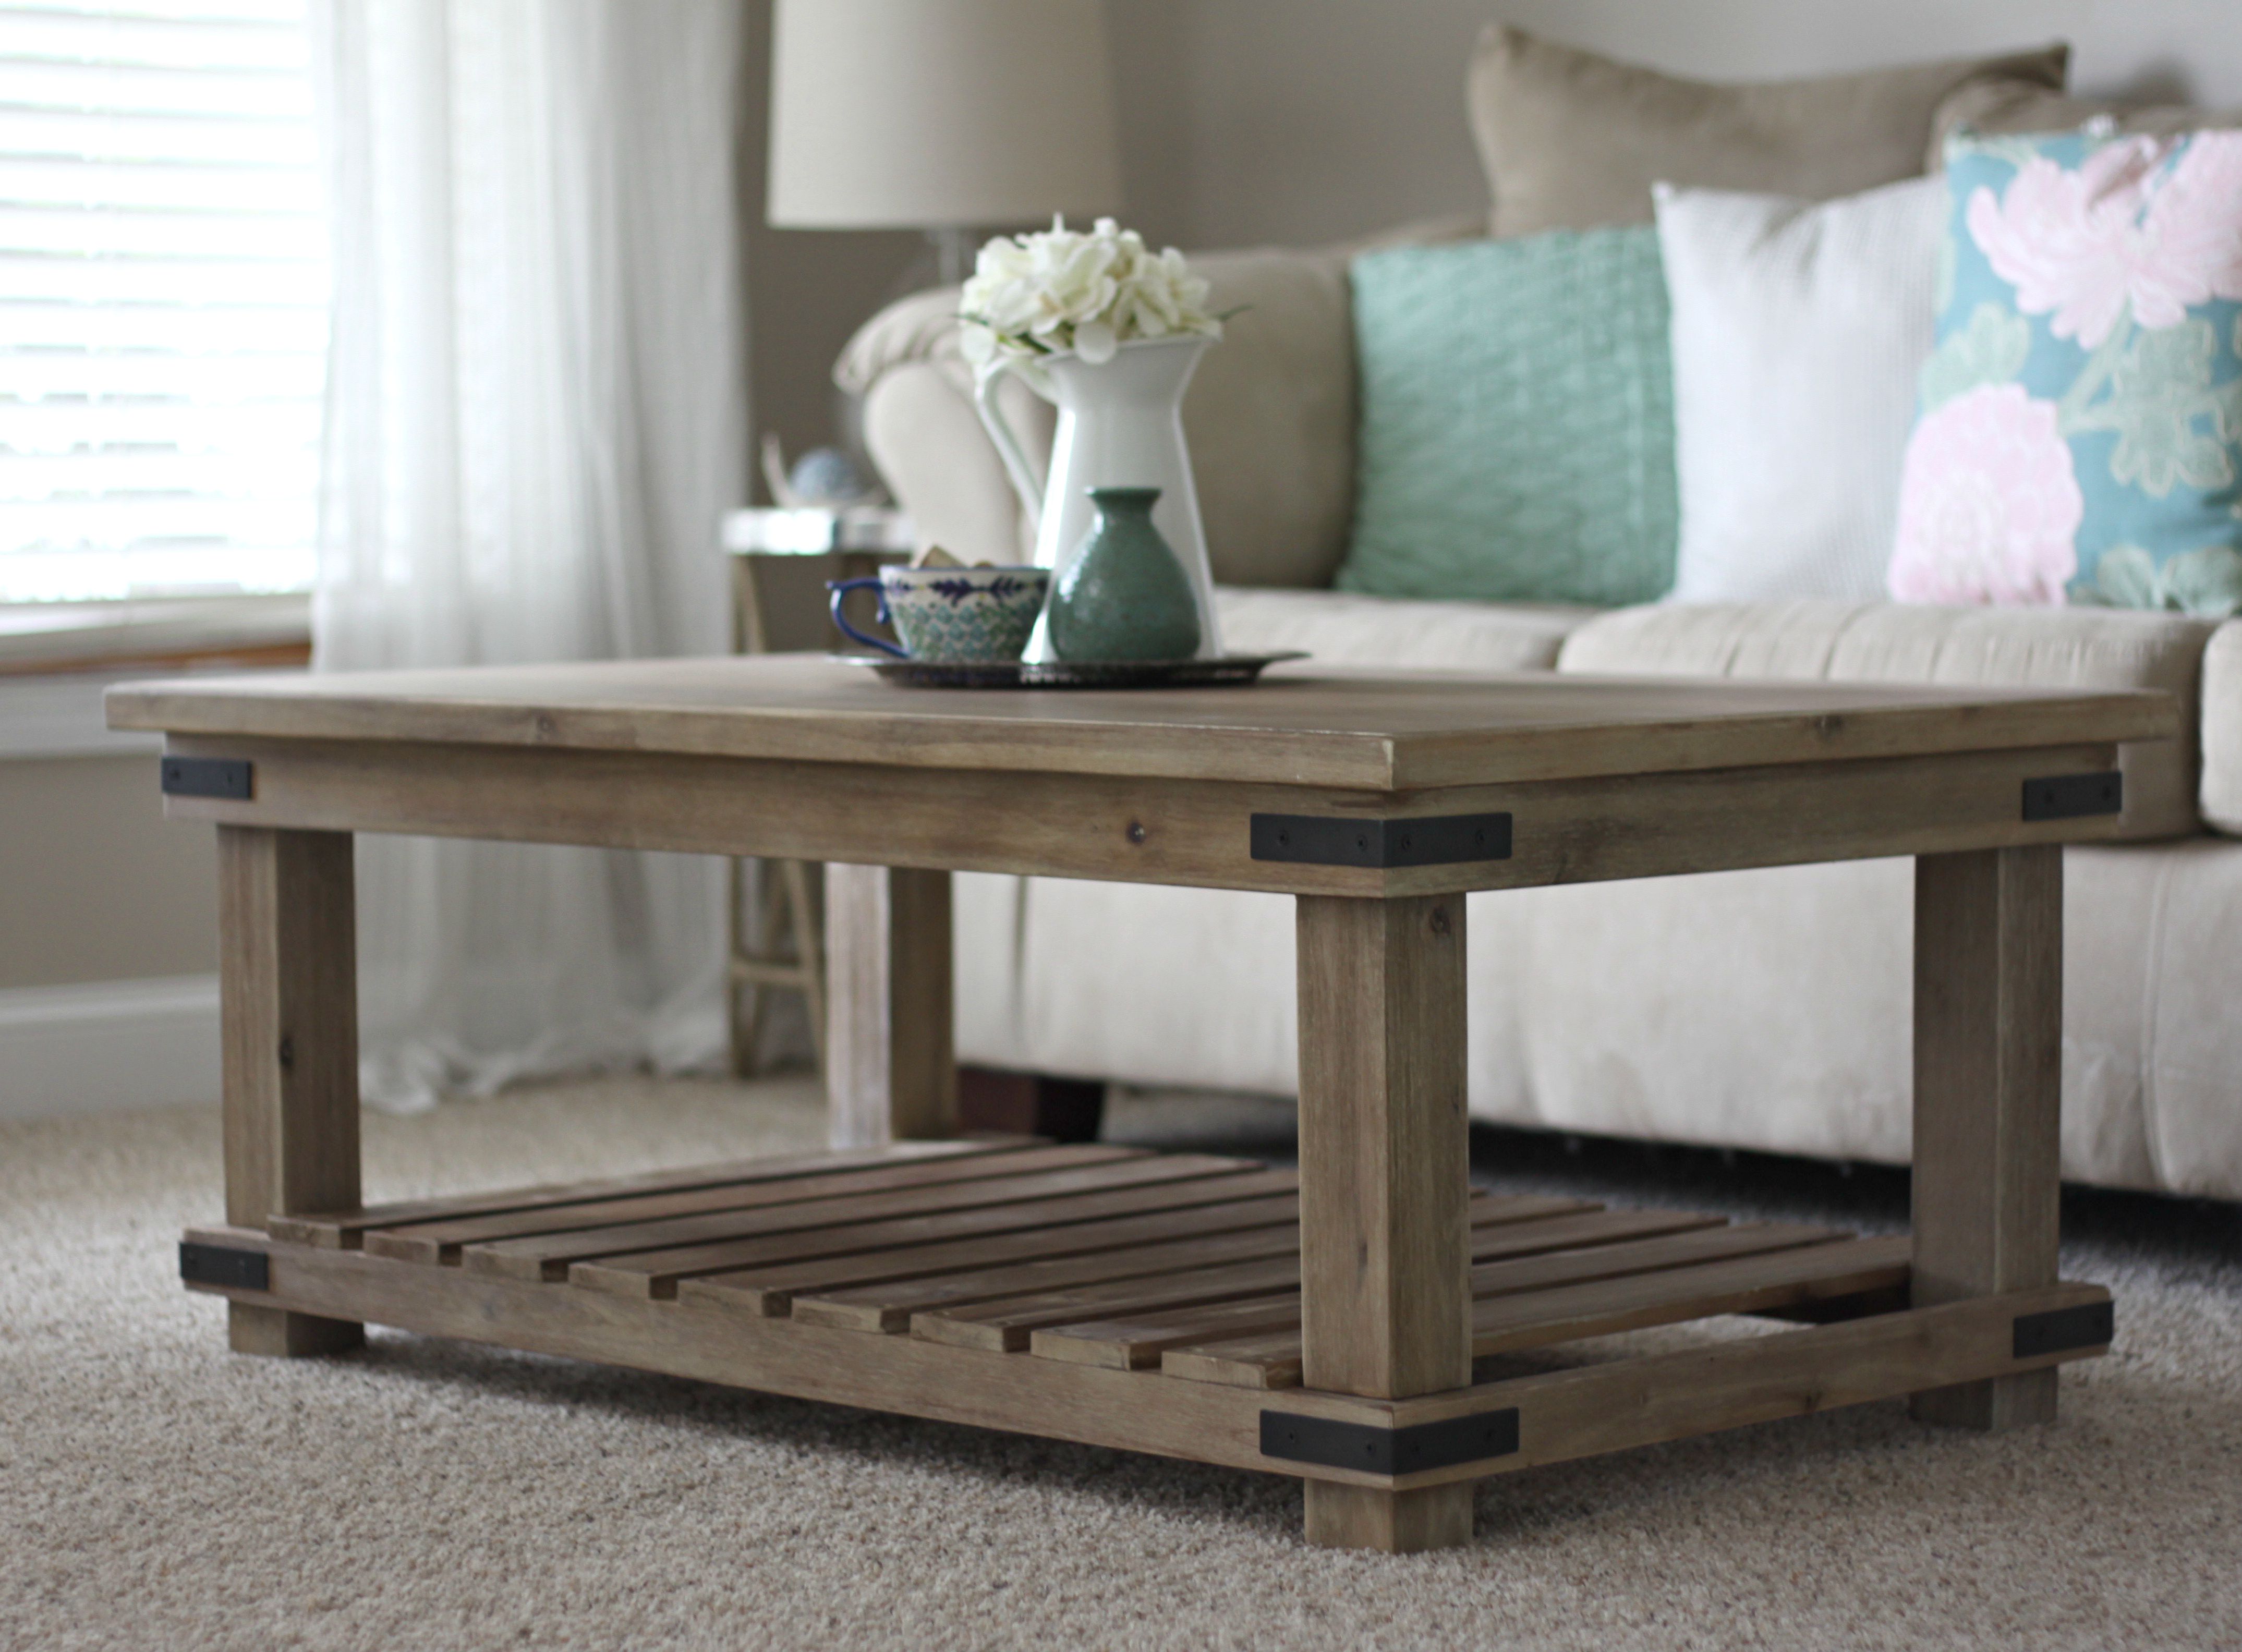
1298;894;1471;1551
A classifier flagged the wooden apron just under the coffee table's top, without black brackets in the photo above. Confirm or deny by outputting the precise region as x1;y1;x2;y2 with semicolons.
136;735;2123;896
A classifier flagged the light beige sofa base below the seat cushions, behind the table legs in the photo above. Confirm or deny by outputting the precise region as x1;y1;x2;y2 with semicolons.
958;839;2242;1199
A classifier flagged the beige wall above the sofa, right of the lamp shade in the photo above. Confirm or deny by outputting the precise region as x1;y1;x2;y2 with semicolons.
1130;0;2242;247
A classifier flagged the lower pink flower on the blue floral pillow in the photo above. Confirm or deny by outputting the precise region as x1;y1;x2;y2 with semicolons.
1885;383;2085;605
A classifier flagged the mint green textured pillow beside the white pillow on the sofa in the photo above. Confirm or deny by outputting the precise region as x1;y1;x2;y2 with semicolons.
1336;224;1679;608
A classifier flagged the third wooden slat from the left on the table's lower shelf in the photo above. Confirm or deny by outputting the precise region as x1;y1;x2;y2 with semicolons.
462;1155;1249;1280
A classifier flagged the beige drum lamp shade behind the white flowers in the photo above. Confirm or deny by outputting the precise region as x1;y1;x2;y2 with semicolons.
767;0;1121;228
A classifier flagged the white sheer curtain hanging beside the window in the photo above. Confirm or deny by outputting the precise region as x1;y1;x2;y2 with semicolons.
312;0;747;1107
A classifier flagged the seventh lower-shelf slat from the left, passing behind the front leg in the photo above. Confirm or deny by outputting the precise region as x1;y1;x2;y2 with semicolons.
910;1210;1686;1352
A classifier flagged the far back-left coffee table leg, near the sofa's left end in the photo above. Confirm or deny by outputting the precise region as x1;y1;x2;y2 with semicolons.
825;865;958;1148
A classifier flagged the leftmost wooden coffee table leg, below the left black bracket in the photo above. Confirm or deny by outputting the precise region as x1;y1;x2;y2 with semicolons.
217;825;366;1354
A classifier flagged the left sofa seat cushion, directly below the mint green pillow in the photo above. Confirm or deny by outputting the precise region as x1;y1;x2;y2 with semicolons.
1215;585;1596;670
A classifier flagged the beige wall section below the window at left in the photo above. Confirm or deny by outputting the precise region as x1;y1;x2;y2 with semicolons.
0;753;217;989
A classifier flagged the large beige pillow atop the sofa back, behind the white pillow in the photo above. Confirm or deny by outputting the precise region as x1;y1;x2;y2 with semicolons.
1471;22;2069;235
